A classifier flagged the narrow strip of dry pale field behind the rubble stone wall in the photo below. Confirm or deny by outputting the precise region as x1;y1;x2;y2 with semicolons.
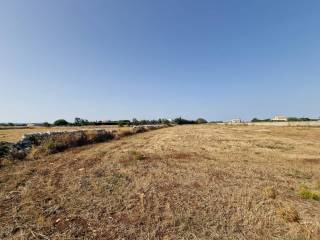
0;125;124;142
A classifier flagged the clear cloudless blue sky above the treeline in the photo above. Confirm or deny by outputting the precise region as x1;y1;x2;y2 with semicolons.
0;0;320;122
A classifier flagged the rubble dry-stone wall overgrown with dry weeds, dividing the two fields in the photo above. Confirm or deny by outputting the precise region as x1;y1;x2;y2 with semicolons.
0;125;172;160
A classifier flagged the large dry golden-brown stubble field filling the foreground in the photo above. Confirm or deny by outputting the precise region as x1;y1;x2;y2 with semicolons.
0;125;320;240
